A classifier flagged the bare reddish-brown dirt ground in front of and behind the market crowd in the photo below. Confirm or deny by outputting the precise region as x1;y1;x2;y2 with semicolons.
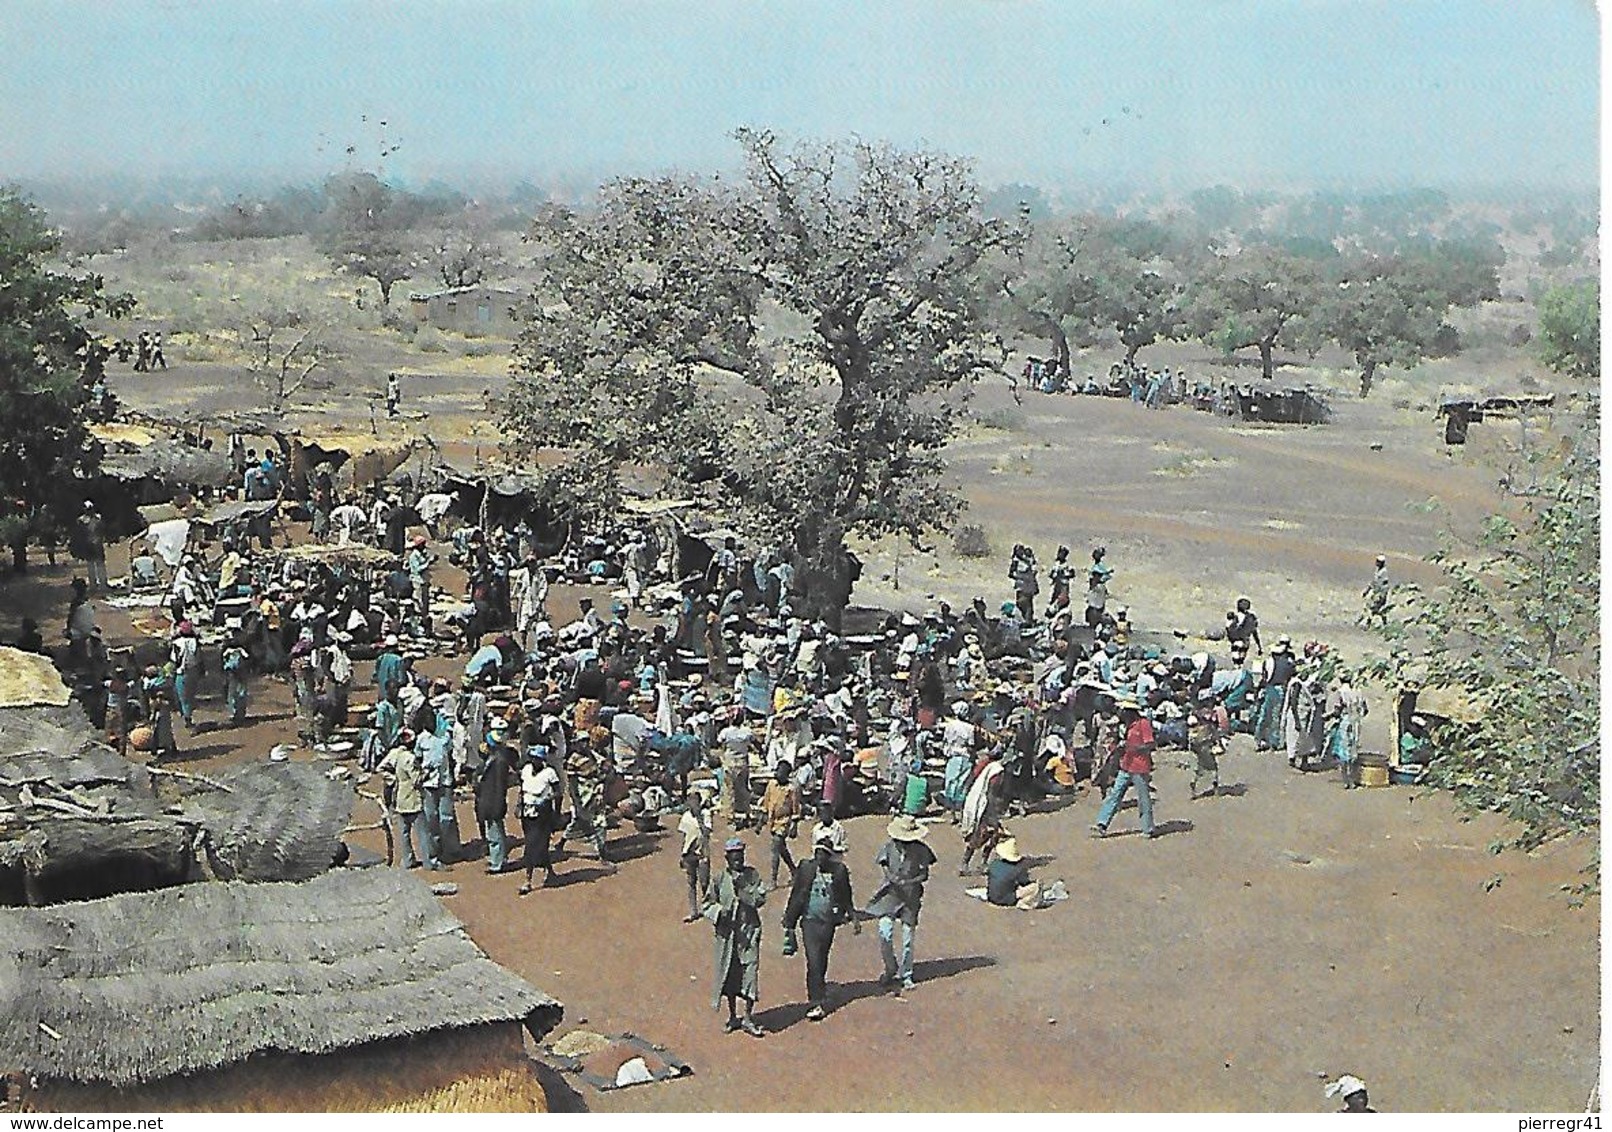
0;338;1601;1113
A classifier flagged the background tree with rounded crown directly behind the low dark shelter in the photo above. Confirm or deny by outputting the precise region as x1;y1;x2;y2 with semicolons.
1186;245;1327;379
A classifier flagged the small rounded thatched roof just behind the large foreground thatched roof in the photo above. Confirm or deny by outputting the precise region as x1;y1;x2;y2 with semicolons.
182;763;355;880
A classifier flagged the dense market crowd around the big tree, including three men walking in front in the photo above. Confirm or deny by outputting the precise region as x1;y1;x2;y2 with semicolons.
31;438;1386;1035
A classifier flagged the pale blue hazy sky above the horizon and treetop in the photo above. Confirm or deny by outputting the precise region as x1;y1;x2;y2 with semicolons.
0;0;1599;189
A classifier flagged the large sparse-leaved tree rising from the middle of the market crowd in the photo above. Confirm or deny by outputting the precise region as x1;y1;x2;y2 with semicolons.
503;129;1019;621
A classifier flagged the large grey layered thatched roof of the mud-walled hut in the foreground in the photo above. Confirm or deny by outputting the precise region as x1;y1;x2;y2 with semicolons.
0;869;563;1085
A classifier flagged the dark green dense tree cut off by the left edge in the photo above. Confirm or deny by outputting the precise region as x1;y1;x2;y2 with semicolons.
0;189;134;568
